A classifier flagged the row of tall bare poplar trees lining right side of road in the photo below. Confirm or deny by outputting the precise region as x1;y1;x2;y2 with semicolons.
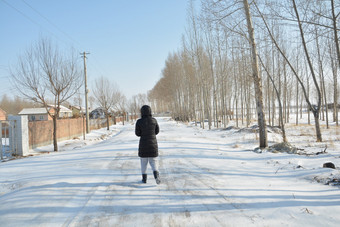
148;0;340;147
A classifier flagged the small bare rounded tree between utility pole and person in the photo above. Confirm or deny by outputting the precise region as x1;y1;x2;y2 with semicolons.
93;76;120;130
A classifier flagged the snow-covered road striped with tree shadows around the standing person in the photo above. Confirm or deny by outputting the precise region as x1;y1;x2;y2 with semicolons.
0;118;340;226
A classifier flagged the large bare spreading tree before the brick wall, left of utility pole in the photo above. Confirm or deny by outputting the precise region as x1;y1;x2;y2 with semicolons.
11;39;82;151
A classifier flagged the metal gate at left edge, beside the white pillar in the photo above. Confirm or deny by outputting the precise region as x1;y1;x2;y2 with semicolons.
0;120;17;161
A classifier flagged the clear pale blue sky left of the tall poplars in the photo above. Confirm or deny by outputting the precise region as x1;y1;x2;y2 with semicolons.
0;0;188;101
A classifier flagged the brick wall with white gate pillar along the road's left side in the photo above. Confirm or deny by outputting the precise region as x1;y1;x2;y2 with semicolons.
0;115;137;157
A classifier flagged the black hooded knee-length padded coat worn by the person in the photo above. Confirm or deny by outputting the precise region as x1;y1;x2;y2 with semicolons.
135;105;159;158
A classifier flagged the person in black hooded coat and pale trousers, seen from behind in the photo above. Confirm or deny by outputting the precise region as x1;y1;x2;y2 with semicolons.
135;105;161;184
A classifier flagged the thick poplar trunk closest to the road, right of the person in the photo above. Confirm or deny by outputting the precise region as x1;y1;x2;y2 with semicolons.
243;0;268;148
